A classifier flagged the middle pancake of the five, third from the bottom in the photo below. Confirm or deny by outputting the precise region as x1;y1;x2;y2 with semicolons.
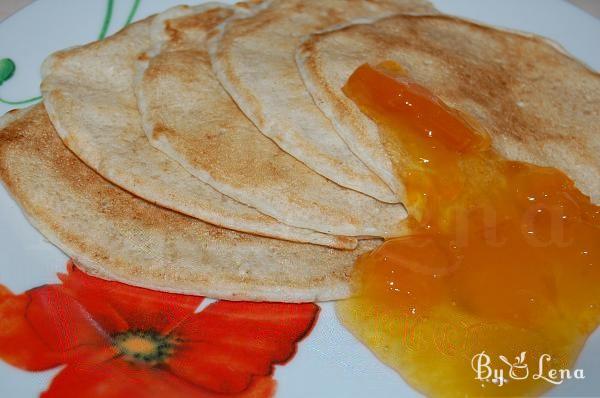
136;7;406;237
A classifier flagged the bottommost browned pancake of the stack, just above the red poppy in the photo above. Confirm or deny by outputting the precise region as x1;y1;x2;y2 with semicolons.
0;105;378;302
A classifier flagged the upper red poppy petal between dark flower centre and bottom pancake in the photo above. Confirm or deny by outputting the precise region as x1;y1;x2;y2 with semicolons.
59;262;203;334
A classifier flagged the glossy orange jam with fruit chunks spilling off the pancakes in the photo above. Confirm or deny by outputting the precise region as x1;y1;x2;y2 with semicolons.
337;62;600;396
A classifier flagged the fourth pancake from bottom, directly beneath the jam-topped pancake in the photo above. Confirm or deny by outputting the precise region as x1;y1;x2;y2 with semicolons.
209;0;433;203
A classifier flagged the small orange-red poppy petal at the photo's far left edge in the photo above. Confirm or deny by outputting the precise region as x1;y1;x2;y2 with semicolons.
0;285;61;371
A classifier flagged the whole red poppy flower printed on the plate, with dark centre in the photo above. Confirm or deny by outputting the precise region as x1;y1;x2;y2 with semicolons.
0;263;318;398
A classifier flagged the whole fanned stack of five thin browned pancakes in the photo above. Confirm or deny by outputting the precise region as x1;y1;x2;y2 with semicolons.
0;0;600;302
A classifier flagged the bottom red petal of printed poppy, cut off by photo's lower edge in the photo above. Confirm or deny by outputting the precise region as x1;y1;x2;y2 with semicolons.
41;358;275;398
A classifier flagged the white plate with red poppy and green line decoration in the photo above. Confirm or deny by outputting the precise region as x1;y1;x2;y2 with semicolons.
0;0;600;398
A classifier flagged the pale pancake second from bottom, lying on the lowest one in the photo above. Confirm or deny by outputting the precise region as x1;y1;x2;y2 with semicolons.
42;10;356;248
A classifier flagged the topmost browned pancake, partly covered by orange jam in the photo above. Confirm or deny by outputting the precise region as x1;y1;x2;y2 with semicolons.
298;16;600;203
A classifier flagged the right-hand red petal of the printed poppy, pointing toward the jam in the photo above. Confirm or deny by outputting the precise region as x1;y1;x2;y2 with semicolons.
169;301;319;393
